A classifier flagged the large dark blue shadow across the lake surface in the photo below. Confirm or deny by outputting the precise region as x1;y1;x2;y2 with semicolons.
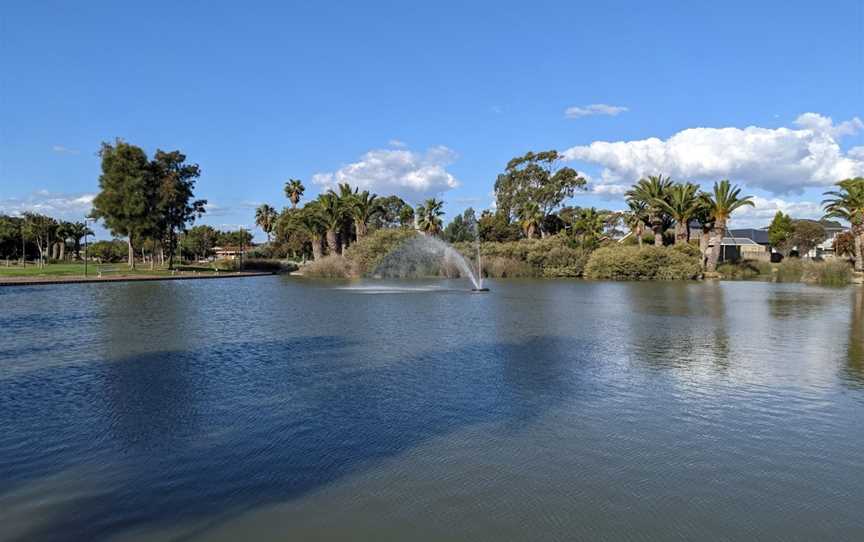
0;337;596;541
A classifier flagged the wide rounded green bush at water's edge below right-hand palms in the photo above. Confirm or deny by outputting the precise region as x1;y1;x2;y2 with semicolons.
585;245;702;280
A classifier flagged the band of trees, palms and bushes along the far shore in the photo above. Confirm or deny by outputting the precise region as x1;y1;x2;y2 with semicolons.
0;140;864;284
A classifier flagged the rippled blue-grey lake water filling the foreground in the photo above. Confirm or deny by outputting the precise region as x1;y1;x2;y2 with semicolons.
0;277;864;541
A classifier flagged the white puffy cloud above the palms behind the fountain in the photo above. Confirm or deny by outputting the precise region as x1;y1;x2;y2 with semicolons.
312;146;459;202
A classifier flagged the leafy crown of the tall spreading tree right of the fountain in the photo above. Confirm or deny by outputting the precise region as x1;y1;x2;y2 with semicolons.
495;150;586;232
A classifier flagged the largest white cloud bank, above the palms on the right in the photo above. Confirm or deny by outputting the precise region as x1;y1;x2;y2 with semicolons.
563;113;864;194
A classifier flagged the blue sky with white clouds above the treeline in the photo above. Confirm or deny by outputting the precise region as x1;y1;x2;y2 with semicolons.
0;0;864;240
